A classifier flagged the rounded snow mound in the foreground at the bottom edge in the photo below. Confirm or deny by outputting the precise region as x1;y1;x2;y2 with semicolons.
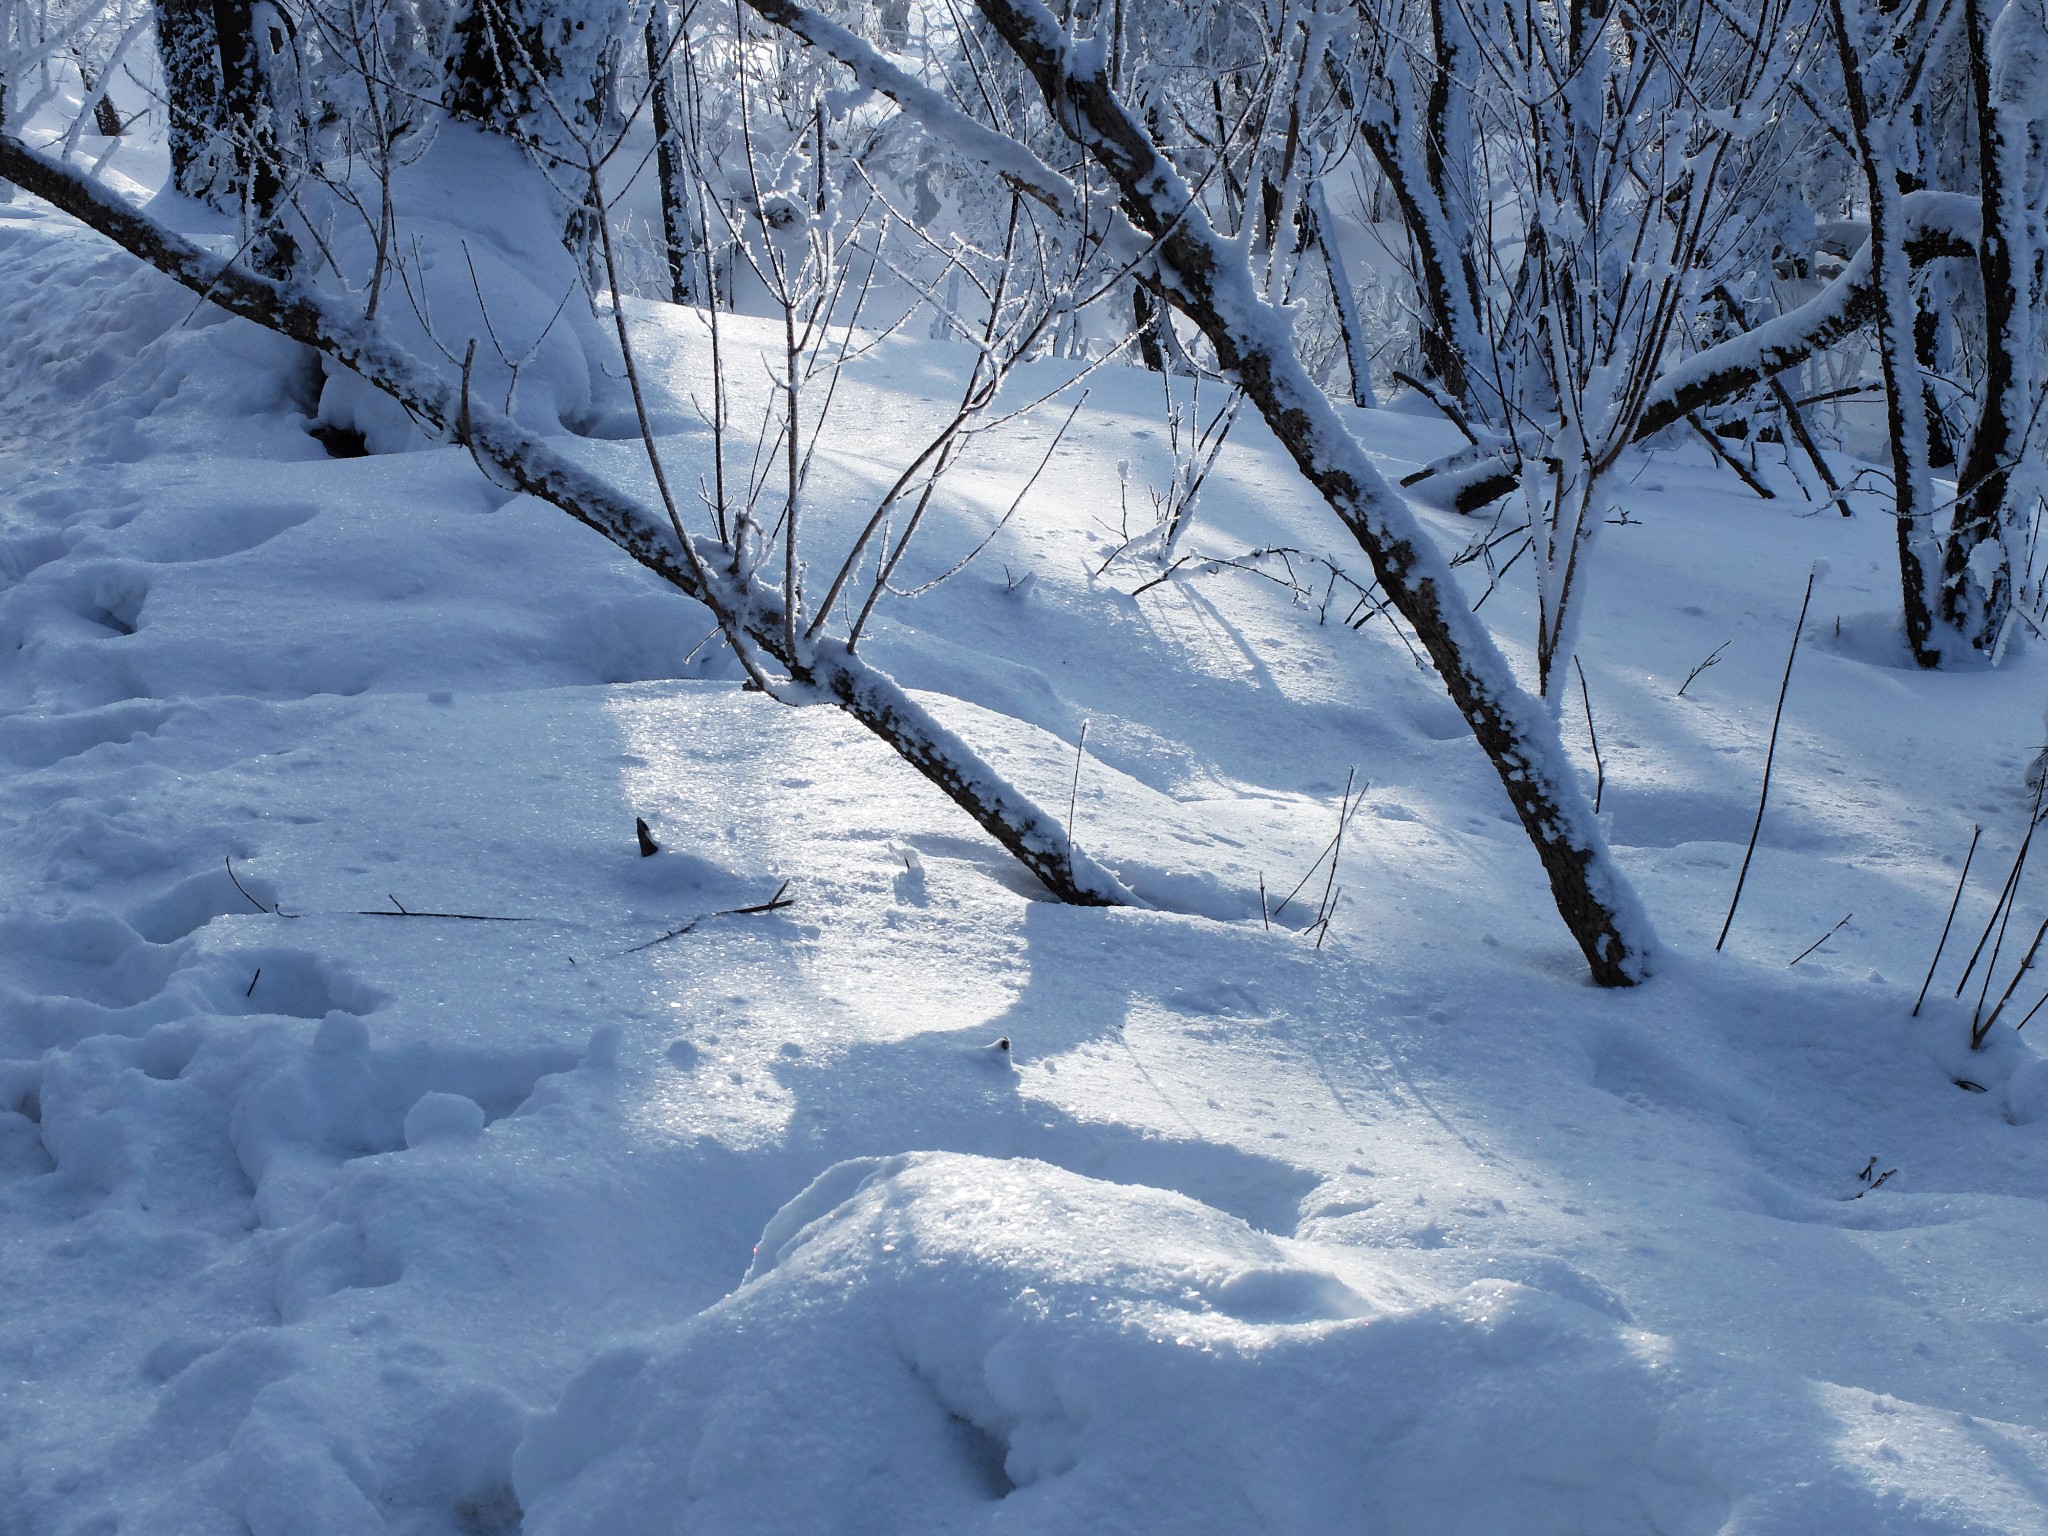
516;1153;1679;1536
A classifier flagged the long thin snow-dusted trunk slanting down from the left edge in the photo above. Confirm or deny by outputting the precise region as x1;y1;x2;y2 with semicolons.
0;133;1130;905
